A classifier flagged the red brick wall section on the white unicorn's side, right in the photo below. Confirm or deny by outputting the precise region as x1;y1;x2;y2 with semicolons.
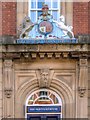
73;2;88;35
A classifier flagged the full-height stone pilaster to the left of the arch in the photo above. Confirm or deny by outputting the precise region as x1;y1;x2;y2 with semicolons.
3;60;14;118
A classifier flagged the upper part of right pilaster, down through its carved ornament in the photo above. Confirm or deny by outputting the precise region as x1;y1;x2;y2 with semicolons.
78;59;88;97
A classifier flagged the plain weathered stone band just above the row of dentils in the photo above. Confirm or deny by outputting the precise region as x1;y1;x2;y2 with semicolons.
0;44;88;53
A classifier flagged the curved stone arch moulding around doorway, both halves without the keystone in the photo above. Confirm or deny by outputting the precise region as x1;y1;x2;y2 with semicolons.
15;76;74;118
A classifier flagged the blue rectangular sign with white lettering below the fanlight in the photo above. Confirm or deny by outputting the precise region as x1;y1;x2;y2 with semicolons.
27;106;61;113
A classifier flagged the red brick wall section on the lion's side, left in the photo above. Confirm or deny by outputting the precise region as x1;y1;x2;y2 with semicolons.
2;2;17;35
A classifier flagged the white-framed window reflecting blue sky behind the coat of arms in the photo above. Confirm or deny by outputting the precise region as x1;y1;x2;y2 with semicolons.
29;0;60;22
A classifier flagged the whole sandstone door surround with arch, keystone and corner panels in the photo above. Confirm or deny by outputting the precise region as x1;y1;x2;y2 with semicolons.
15;59;77;118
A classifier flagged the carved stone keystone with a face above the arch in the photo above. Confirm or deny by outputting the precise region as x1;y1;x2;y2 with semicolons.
36;68;54;88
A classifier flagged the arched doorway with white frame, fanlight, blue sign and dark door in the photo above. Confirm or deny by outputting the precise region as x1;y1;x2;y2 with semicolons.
25;89;62;120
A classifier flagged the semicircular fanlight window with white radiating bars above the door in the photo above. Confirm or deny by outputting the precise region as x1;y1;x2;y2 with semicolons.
27;89;61;105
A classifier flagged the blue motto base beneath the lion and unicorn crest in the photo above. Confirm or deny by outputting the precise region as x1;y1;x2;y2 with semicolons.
16;38;78;44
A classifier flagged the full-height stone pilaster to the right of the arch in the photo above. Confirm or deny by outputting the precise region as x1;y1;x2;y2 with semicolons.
77;58;88;118
